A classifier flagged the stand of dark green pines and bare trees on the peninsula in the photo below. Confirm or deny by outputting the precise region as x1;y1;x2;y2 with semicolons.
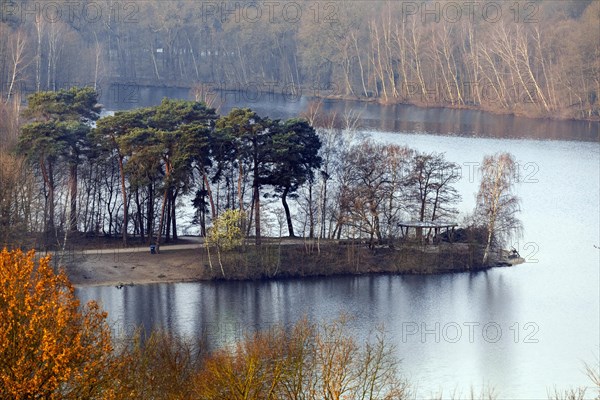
0;88;519;264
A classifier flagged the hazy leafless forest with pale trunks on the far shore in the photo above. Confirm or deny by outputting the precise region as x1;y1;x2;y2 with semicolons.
0;0;600;120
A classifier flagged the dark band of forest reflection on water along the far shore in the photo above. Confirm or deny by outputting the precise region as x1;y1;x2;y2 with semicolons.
100;85;600;142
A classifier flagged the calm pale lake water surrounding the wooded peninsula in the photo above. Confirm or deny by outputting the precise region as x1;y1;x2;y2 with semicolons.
77;88;600;399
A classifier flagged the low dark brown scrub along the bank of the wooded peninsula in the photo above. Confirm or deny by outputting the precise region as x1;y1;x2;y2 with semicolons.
202;242;479;280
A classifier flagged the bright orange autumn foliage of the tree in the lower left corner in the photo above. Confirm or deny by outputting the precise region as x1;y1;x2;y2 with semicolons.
0;249;113;399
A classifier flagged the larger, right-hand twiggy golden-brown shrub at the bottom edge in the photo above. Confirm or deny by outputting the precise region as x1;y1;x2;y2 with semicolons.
195;318;408;400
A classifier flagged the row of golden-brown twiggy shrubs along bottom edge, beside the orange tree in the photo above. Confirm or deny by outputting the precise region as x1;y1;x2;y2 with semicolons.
105;318;409;400
